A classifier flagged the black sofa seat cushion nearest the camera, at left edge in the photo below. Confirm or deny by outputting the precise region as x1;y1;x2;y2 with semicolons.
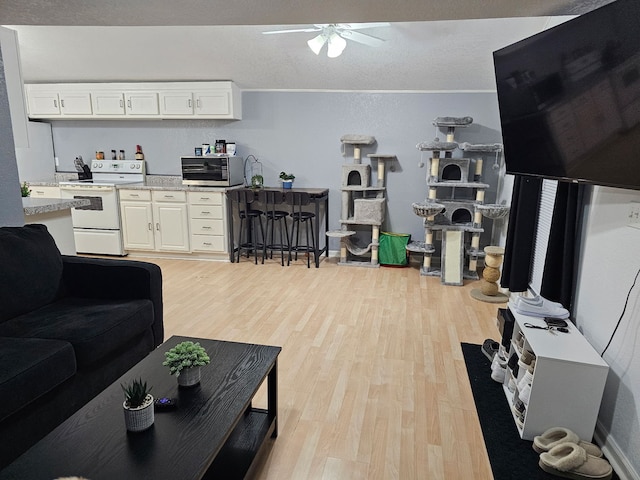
0;337;76;420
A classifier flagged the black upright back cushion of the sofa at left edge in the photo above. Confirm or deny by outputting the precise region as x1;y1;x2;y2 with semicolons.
0;224;62;322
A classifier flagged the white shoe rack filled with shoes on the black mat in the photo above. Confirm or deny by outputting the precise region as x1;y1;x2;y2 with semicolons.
503;306;609;440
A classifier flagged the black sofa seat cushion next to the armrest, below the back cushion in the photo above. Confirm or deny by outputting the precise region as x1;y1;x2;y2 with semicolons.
0;297;153;369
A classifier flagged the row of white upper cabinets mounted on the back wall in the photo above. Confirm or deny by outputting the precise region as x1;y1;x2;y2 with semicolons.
25;82;242;120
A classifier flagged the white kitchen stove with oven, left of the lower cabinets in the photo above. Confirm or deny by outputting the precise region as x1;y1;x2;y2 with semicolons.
60;160;146;255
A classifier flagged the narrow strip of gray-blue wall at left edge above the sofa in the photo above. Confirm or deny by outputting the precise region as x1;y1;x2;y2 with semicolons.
0;39;24;226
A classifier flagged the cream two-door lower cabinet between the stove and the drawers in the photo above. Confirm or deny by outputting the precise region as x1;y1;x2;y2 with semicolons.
120;189;189;252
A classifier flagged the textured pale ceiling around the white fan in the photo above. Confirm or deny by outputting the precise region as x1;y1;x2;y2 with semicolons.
0;0;607;91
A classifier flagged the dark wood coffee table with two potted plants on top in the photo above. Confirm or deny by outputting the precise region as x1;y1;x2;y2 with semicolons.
0;337;281;480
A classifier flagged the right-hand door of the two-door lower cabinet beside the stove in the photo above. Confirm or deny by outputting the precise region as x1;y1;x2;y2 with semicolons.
153;203;189;252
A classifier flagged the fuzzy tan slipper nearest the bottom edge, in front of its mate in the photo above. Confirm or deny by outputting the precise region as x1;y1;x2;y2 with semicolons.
538;442;613;480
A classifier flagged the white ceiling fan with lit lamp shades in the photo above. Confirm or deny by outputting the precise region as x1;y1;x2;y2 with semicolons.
262;22;391;58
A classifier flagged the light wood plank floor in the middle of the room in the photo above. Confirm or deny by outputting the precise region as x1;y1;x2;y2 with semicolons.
151;253;500;480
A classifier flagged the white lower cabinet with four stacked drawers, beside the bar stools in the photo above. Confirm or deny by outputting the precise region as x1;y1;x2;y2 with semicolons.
187;192;227;253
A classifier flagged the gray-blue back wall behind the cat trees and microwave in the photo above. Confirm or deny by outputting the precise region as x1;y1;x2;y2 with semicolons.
52;91;501;249
